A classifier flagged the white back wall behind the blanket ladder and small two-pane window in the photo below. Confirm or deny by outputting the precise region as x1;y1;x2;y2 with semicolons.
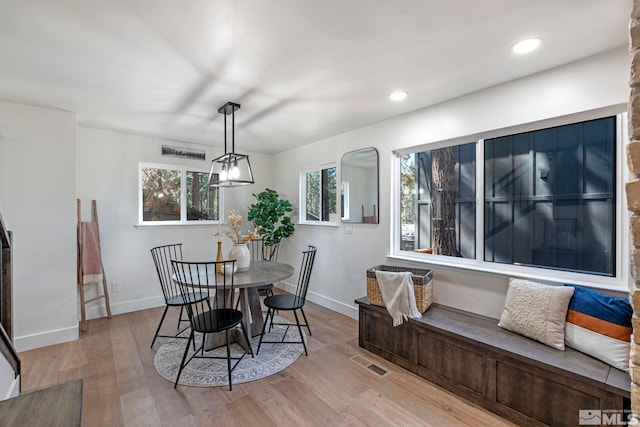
77;127;272;320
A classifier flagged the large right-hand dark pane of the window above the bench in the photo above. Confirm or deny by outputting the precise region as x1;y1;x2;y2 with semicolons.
485;117;616;276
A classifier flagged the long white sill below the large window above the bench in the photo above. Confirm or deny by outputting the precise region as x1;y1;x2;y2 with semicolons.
387;252;629;293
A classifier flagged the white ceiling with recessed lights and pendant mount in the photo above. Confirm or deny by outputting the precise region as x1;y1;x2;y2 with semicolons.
0;0;632;153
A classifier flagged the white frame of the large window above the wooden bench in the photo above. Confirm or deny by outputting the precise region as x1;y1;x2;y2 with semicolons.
388;106;630;291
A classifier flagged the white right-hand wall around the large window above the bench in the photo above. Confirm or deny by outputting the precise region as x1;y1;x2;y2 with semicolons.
274;48;629;318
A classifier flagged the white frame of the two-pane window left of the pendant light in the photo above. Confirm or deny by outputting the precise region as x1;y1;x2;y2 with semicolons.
137;162;224;227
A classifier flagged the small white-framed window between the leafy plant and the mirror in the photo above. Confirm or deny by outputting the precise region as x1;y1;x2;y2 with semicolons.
300;166;339;224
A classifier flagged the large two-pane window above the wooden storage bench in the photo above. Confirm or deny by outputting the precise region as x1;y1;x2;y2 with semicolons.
394;116;621;277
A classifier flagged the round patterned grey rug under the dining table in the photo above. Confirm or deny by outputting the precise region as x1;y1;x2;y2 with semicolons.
154;316;306;387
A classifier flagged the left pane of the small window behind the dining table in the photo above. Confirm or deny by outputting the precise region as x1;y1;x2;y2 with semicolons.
142;168;181;221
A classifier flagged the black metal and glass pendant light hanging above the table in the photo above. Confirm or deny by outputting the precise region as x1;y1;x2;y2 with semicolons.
209;102;253;187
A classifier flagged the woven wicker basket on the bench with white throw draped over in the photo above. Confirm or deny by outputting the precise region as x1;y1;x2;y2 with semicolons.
367;265;433;313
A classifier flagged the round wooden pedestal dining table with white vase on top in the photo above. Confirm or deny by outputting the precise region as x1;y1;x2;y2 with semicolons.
175;261;295;350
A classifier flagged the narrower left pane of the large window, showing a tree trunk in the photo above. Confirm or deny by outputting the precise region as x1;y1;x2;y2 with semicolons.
400;143;476;258
